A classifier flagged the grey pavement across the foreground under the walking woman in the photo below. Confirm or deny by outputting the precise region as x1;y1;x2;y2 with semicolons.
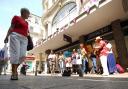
0;75;128;89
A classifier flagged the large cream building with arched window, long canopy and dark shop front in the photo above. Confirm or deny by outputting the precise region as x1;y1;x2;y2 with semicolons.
33;0;128;72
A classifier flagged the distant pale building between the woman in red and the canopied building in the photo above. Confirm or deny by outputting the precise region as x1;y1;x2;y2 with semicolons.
25;14;43;72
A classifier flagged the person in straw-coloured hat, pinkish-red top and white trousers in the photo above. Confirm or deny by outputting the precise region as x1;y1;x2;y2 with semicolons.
95;36;109;76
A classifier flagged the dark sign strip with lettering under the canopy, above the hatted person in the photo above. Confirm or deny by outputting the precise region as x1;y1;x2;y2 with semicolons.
85;25;112;40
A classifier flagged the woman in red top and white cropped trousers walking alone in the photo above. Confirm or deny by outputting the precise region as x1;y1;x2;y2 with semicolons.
4;8;30;80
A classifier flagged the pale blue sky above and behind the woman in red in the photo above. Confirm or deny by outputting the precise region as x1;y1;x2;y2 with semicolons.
0;0;43;48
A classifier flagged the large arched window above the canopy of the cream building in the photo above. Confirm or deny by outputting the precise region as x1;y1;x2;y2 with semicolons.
52;2;77;25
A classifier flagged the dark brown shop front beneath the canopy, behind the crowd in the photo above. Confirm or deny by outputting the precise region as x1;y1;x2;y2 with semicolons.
55;20;128;68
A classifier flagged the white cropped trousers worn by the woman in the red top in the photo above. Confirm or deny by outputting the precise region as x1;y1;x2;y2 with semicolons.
9;32;28;64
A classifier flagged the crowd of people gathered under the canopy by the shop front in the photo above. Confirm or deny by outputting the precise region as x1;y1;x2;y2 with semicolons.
48;36;123;77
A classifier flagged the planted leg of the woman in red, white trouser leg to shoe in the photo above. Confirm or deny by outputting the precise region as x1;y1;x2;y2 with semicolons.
10;34;20;80
